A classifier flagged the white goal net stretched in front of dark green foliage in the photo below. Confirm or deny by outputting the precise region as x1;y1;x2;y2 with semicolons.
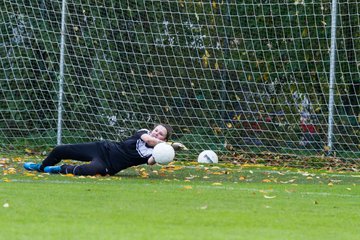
0;0;360;164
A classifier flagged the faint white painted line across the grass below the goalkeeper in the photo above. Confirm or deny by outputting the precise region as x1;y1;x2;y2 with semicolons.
11;179;360;198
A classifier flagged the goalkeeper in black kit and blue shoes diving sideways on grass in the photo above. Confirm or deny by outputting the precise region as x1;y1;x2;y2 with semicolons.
24;124;186;176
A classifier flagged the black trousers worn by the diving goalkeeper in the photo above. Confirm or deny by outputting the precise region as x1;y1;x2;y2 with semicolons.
41;142;109;175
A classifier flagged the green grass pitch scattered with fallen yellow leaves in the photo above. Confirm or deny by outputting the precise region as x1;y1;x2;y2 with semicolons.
0;157;360;240
